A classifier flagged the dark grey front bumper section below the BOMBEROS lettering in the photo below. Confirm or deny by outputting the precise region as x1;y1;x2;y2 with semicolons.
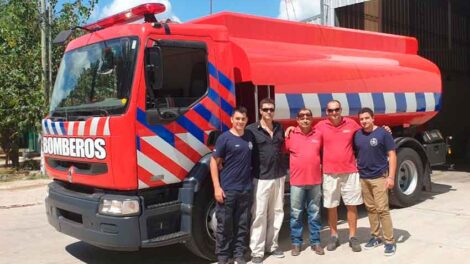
46;182;140;251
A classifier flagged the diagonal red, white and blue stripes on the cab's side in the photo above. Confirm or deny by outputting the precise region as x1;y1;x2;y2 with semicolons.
136;63;235;189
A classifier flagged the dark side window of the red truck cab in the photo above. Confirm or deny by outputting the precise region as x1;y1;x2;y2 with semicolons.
146;46;208;122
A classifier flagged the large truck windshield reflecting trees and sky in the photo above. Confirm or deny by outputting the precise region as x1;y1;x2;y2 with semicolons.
49;38;137;119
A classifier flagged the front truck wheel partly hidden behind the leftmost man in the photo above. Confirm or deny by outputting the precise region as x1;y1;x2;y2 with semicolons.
186;181;217;261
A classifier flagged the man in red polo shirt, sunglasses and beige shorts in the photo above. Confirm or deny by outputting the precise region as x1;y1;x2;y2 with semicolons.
315;100;363;252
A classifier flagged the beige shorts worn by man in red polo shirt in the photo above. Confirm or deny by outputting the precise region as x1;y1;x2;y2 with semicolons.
323;172;363;208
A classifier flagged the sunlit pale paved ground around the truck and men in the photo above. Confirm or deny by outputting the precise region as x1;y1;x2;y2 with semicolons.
0;168;470;264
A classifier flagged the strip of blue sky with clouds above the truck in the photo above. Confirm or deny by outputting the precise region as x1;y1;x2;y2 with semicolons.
81;0;320;22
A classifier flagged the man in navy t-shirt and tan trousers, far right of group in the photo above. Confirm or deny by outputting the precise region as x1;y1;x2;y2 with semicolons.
354;107;397;256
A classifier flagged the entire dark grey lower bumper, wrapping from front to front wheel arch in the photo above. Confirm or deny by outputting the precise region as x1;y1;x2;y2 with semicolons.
45;182;192;251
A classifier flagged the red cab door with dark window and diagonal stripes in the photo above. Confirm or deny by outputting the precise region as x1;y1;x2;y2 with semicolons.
137;36;228;189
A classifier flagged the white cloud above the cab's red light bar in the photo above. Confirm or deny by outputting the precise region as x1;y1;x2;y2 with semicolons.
92;0;181;22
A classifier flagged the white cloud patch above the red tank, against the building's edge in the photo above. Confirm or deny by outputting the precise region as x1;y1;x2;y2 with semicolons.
278;0;320;21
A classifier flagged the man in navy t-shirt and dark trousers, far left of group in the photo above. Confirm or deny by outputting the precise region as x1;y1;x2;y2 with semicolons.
210;107;254;263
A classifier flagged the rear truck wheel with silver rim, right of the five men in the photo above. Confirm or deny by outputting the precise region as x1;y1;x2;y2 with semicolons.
390;148;424;207
